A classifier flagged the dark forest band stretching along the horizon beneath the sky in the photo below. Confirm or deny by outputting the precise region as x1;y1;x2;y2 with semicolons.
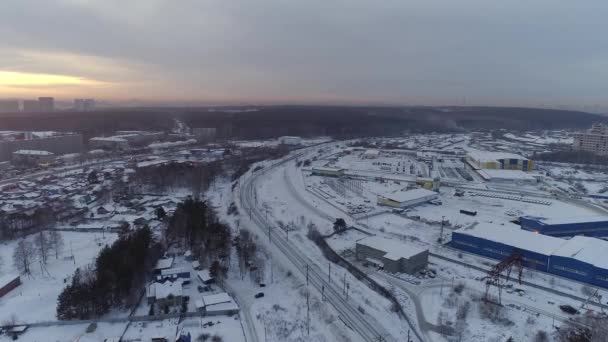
0;106;603;139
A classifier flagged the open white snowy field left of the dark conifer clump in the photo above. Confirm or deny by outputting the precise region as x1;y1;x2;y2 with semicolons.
0;232;116;323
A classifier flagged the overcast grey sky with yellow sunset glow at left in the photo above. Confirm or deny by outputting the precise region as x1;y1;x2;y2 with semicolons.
0;0;608;106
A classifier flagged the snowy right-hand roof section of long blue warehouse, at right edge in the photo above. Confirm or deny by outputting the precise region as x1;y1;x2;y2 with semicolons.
553;236;608;269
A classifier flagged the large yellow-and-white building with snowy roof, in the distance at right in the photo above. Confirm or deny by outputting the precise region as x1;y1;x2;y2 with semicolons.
467;151;534;171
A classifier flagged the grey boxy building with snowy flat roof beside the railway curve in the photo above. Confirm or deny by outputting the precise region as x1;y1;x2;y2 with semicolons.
355;236;429;274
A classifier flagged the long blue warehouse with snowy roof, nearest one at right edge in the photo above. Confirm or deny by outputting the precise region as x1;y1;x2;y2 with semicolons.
450;223;608;288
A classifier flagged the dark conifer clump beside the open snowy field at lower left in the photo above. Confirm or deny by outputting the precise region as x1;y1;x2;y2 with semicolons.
57;226;162;320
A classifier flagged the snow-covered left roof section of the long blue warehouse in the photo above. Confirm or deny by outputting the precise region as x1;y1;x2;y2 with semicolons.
454;223;566;255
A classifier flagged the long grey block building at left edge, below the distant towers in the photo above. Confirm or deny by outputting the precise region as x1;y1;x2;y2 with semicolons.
0;134;83;161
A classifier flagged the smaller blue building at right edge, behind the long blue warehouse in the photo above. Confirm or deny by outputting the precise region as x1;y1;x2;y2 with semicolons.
519;216;608;237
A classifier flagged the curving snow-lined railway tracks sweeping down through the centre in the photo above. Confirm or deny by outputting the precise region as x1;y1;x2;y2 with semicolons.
237;152;404;341
